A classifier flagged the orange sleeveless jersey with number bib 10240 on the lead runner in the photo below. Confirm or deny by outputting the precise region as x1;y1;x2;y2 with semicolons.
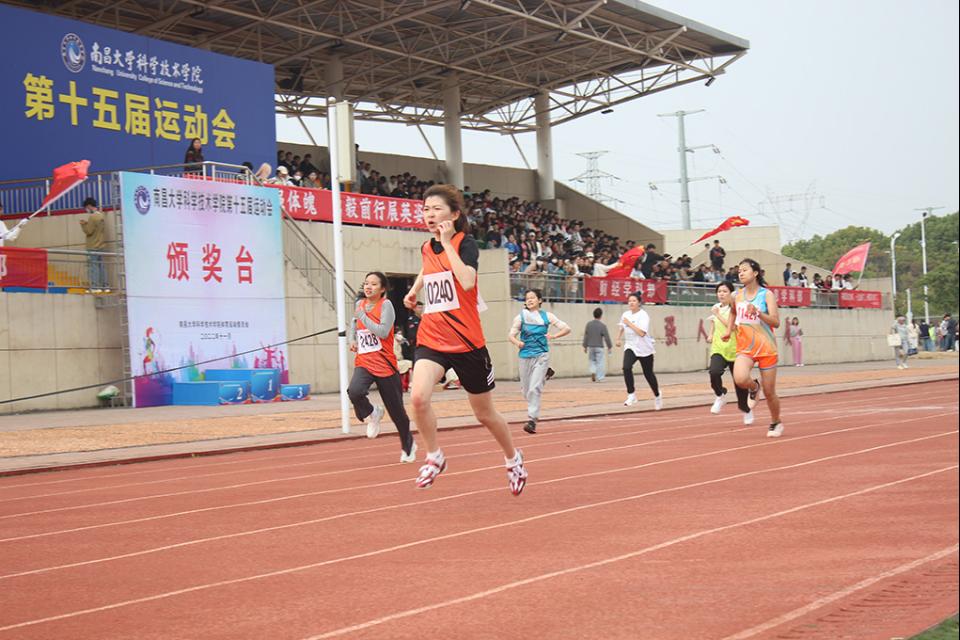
417;232;486;353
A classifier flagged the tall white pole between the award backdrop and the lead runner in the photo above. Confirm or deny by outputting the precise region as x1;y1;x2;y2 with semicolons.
327;99;350;434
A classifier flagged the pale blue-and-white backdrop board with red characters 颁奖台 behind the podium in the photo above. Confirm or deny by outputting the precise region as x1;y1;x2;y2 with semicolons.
120;172;288;407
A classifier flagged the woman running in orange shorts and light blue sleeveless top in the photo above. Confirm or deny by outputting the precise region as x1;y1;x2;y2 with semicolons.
725;258;783;438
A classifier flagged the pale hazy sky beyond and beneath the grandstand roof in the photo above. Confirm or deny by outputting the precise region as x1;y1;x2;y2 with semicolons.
277;0;960;242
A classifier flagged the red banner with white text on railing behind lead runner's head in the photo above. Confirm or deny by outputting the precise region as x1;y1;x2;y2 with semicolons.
269;185;427;231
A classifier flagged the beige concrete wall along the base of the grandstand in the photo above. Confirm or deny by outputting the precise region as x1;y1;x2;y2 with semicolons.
0;244;890;412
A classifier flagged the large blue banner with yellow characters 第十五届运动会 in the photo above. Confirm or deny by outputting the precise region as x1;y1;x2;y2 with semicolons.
0;5;276;180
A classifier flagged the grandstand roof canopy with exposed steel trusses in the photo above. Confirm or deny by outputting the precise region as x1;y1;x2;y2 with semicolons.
11;0;750;133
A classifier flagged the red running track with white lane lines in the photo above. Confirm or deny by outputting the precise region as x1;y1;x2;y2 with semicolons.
0;381;960;640
